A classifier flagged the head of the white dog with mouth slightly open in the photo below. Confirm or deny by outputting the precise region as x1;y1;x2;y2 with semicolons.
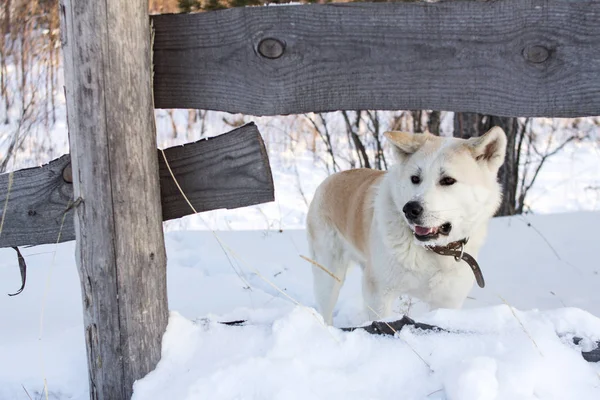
385;127;506;246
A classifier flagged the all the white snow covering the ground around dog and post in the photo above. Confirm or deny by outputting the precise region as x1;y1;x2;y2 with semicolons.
0;212;600;400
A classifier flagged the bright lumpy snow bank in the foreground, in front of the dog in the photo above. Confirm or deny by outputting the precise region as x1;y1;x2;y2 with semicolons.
133;306;600;400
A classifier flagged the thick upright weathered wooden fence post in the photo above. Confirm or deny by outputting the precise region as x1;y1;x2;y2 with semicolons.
61;0;168;400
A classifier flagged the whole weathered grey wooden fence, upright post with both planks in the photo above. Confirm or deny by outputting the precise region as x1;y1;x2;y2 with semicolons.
0;0;600;399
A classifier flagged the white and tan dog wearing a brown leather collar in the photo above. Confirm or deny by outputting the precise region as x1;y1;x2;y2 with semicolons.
307;127;506;325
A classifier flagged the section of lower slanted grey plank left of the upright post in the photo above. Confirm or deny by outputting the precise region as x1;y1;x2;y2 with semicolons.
0;155;75;247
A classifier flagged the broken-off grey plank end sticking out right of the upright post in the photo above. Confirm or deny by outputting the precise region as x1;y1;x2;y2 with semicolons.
158;124;274;221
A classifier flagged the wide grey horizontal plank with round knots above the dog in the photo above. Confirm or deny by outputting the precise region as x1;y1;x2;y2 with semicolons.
153;0;600;117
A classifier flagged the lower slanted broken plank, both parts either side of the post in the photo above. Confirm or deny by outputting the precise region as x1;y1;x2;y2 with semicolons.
0;124;274;247
